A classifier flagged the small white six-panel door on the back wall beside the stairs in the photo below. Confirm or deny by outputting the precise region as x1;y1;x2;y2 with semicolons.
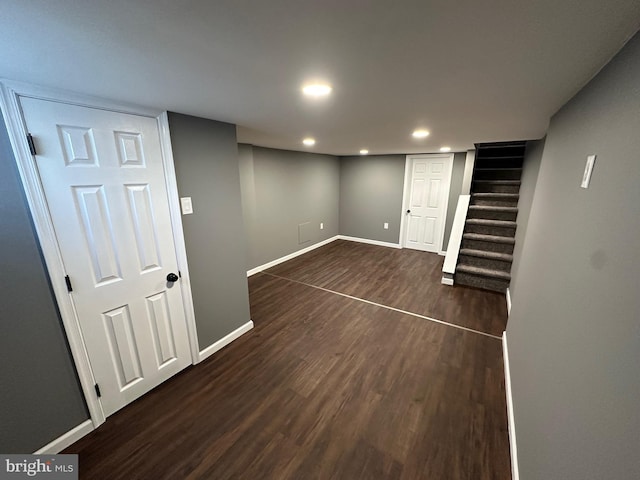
403;155;452;253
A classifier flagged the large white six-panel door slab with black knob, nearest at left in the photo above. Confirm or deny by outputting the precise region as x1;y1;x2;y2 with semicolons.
20;97;191;416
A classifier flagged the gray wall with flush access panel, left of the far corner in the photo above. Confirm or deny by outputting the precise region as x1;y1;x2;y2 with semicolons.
239;145;340;269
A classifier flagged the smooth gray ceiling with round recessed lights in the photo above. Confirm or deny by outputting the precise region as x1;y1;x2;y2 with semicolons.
0;0;640;155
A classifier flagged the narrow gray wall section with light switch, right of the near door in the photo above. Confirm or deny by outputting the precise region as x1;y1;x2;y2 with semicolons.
169;113;250;349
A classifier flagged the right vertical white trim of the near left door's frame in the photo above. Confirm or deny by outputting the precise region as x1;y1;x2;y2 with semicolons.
158;112;200;365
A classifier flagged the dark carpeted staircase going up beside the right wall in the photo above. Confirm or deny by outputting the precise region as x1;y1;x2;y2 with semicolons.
455;142;526;293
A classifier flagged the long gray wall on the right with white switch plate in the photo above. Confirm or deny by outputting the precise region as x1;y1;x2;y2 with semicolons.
507;31;640;480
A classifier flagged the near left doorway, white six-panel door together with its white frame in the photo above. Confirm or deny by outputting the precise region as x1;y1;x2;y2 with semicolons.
3;85;198;427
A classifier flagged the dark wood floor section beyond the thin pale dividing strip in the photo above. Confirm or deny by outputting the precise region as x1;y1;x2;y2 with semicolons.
266;240;507;336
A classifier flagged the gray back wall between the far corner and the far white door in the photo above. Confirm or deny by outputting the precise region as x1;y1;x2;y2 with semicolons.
340;155;406;243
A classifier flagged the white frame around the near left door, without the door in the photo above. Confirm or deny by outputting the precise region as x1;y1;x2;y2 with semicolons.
0;80;200;428
